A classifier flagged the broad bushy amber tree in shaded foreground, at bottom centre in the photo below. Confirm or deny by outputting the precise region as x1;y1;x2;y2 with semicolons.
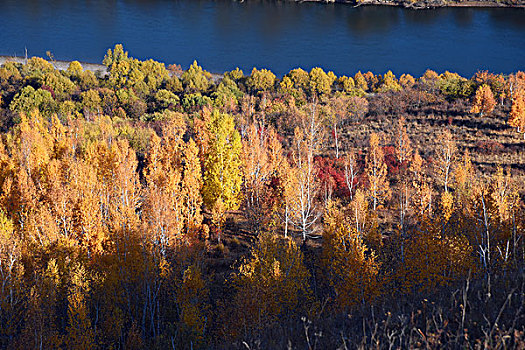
232;233;312;329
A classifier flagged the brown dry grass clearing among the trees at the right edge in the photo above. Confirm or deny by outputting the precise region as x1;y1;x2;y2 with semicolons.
338;95;525;192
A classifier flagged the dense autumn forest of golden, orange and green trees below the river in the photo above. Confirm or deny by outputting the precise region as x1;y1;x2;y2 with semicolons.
0;45;525;349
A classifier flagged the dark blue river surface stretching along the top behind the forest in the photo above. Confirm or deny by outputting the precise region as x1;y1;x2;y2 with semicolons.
0;0;525;76
